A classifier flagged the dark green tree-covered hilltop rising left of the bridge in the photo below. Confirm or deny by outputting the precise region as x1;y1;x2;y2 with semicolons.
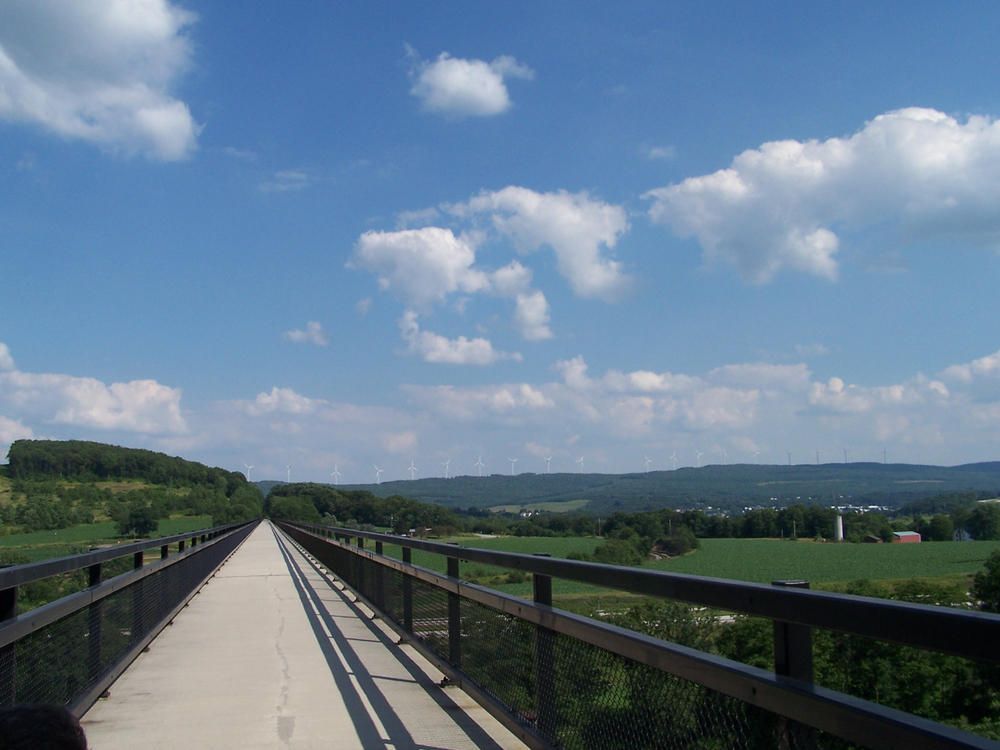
7;440;247;497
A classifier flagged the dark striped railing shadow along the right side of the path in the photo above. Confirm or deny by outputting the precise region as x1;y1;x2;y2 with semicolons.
271;526;502;750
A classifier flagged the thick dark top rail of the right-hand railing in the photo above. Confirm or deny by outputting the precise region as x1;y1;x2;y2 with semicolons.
295;524;1000;663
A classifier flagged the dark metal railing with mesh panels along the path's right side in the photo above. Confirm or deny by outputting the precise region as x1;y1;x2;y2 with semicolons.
277;522;1000;750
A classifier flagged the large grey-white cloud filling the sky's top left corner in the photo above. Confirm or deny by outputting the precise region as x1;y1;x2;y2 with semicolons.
0;0;200;161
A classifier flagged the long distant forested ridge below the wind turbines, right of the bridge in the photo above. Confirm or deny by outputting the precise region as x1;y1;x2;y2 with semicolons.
344;462;1000;513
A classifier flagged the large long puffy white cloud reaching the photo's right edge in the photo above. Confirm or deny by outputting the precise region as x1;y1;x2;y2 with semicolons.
646;107;1000;284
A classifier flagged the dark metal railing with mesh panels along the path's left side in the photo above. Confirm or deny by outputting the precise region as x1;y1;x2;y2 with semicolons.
0;521;257;717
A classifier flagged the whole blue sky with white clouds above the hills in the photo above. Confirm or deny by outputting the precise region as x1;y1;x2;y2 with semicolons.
0;0;1000;482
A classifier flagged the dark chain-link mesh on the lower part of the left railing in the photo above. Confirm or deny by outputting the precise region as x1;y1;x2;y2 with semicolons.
0;529;249;706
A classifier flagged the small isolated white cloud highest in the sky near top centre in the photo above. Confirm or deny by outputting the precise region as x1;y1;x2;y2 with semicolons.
410;52;535;117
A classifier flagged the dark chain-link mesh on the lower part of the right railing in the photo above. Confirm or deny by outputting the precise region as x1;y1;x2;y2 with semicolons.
282;531;854;750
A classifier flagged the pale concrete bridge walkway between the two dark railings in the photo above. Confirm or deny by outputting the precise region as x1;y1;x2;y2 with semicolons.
83;523;524;750
